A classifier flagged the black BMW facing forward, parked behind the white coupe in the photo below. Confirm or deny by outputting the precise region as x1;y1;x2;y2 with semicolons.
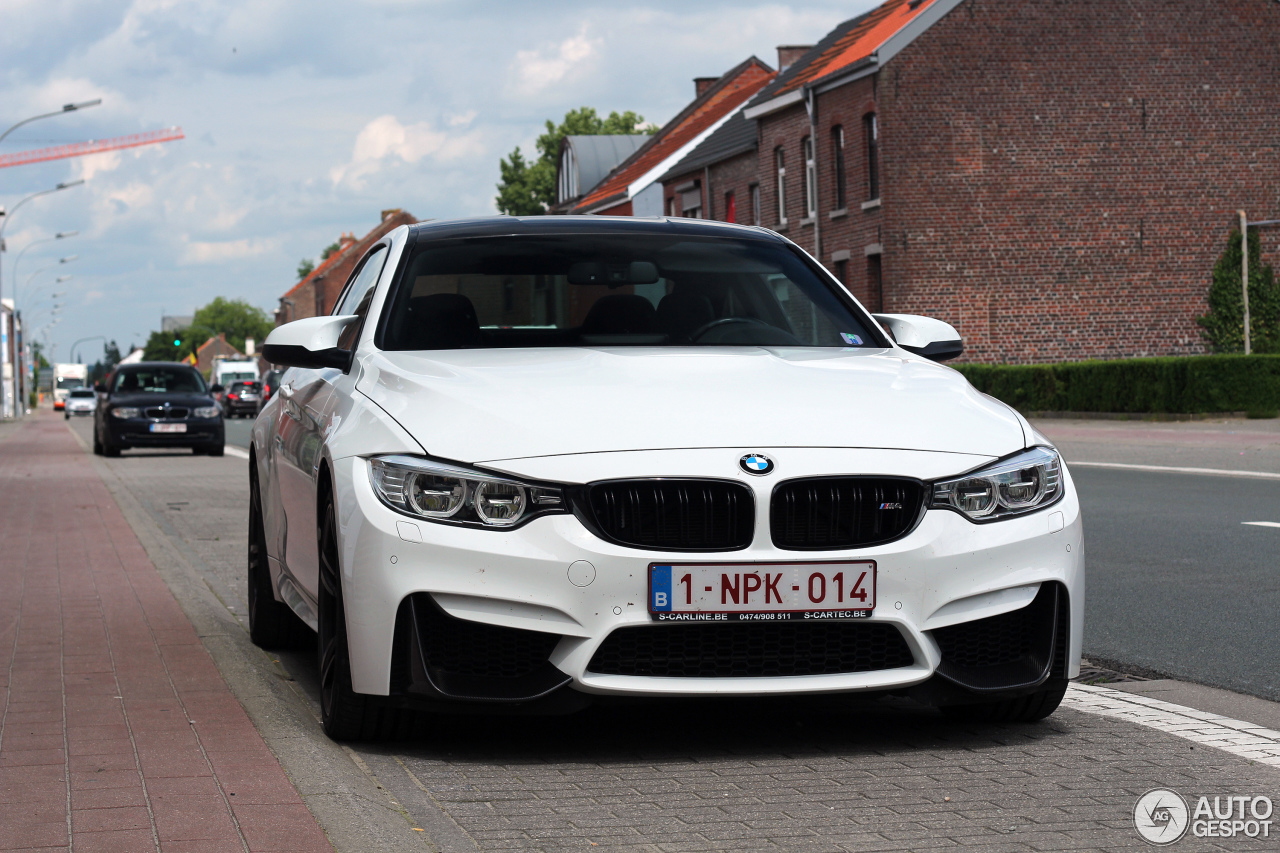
93;361;225;456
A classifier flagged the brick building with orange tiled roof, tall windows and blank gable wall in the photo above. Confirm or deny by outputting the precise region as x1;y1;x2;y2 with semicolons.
662;0;1280;362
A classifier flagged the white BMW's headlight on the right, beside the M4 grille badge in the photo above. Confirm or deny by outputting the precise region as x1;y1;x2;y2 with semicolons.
929;447;1062;521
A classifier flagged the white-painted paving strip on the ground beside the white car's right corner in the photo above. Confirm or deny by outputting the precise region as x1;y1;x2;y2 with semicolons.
1062;684;1280;767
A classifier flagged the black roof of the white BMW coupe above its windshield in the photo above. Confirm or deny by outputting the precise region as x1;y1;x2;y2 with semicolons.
408;215;786;243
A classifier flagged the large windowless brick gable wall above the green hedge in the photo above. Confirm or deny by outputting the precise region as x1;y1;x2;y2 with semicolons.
878;0;1280;362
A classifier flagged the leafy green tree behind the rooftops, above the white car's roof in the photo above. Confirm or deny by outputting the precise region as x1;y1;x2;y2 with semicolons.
494;106;658;216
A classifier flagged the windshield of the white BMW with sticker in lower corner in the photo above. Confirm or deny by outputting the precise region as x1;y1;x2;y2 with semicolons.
380;233;879;350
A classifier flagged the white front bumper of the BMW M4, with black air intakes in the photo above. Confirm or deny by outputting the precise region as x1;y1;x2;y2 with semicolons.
325;451;1084;703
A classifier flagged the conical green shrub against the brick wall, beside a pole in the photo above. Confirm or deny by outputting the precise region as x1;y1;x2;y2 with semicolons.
1196;229;1280;352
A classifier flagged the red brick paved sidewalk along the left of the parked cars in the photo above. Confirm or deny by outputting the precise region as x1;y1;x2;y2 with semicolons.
0;412;333;853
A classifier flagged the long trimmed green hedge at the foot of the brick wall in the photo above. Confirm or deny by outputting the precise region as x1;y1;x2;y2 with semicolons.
955;355;1280;414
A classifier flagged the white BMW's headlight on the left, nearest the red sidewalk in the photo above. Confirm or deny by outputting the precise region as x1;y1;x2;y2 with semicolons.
369;456;568;528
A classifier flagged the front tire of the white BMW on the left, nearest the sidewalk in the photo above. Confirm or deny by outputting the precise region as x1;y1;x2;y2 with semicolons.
316;497;412;740
